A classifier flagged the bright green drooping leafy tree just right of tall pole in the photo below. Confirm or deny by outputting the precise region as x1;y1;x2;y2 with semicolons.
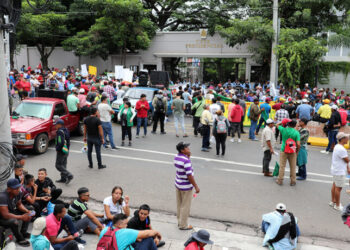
275;29;327;86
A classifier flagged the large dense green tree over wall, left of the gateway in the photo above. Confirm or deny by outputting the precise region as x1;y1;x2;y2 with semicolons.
63;0;155;65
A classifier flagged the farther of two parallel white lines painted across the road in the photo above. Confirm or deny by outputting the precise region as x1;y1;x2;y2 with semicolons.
71;140;332;178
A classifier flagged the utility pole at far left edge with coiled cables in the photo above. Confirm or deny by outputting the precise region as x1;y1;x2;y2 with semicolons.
0;16;12;191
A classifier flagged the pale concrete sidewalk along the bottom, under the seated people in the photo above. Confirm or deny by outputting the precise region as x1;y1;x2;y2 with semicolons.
16;200;342;250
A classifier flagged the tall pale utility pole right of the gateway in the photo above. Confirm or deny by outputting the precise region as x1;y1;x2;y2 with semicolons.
270;0;279;93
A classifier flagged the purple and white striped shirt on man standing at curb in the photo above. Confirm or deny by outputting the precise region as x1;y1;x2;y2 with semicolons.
174;153;193;191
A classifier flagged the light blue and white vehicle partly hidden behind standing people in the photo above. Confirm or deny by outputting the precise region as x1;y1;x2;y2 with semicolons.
112;87;173;126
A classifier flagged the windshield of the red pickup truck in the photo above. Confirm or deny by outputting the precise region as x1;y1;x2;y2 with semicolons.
15;102;52;119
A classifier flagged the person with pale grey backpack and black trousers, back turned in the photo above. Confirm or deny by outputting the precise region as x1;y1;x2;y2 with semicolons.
213;110;230;156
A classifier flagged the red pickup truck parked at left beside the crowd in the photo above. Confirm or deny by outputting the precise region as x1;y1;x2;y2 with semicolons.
11;97;83;154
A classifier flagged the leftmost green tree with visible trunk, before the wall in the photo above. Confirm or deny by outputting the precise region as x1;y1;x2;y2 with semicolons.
16;0;68;69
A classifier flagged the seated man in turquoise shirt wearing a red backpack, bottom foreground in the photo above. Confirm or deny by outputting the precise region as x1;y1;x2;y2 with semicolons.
96;214;162;250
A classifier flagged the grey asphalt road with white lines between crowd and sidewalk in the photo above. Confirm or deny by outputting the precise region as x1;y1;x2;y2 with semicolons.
21;118;349;241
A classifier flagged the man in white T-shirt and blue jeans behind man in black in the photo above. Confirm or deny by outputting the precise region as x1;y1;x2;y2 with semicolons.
98;96;117;149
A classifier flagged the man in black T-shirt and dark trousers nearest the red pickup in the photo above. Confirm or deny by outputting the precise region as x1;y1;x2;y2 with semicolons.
84;107;106;169
